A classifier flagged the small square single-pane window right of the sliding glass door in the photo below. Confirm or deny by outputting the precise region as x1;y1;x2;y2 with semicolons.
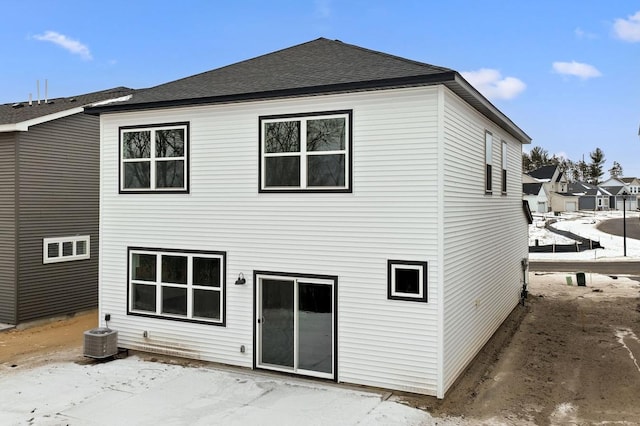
387;260;427;302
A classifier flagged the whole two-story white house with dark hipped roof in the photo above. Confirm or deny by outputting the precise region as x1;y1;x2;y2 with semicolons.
88;38;530;397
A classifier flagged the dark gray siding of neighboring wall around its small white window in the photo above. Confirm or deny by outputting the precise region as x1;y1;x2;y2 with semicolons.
18;114;99;322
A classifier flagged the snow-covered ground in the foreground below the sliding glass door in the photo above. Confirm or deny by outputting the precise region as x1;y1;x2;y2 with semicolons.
0;356;470;426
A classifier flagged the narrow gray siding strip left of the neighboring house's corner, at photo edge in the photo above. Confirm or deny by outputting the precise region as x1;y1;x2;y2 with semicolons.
0;133;16;324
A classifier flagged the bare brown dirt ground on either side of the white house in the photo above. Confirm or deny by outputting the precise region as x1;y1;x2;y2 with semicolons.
0;273;640;425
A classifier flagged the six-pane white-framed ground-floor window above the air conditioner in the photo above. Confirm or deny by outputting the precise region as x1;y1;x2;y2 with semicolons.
128;247;226;325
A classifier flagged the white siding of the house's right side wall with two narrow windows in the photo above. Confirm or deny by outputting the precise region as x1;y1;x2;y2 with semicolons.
440;89;528;396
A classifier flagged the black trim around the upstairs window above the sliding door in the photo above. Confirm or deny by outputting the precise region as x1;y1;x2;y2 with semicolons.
258;109;353;194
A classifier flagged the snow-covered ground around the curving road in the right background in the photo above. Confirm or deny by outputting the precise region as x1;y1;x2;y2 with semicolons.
529;211;640;260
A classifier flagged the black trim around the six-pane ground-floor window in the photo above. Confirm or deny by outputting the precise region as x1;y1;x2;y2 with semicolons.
126;246;227;327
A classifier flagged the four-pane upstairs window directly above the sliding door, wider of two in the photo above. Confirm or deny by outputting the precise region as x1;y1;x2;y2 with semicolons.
259;110;352;192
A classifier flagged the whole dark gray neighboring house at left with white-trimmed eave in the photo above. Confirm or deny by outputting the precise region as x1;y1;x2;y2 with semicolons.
0;88;131;324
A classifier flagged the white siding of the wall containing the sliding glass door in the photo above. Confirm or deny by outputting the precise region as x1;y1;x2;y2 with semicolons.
100;88;441;394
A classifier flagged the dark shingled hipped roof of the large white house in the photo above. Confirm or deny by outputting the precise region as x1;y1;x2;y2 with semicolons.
88;38;531;143
